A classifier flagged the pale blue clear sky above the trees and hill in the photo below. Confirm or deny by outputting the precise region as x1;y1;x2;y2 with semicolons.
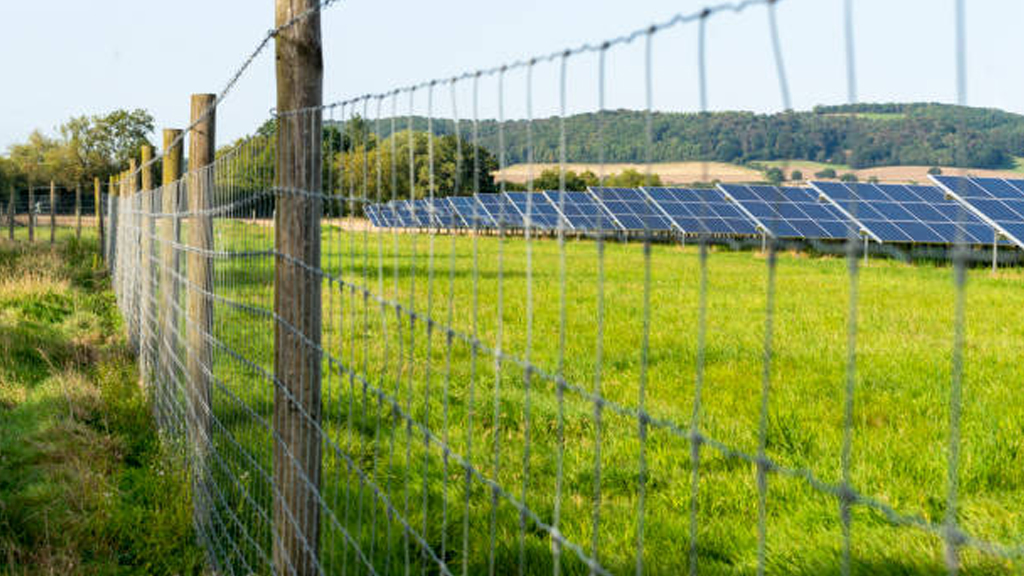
0;0;1024;150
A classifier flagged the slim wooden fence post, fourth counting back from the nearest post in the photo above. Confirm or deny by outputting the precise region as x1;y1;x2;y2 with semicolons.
138;146;157;383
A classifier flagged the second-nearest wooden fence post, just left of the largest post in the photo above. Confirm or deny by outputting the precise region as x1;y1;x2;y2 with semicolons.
185;94;216;526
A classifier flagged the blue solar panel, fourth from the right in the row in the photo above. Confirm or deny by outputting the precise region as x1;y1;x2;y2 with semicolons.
640;187;760;236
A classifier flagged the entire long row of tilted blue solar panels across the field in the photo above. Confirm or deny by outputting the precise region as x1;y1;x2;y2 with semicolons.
366;182;1024;248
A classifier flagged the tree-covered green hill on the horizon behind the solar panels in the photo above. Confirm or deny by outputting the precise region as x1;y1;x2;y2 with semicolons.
350;104;1024;168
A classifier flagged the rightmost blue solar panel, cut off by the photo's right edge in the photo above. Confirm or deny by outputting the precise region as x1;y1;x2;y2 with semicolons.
932;176;1024;248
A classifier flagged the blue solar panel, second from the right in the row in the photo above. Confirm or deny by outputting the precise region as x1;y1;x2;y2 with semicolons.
811;182;993;244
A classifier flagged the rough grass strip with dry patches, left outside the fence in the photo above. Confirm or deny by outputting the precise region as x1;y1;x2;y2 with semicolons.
0;230;204;576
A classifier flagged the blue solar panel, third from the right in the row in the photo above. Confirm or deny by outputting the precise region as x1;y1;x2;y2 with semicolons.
719;184;864;240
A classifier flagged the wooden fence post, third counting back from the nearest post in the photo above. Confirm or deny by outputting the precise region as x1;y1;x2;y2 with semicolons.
158;130;182;391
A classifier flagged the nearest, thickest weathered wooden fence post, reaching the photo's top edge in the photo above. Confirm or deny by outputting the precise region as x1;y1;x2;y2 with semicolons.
273;0;324;576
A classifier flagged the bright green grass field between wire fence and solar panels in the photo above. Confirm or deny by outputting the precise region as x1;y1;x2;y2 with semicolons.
193;220;1024;574
